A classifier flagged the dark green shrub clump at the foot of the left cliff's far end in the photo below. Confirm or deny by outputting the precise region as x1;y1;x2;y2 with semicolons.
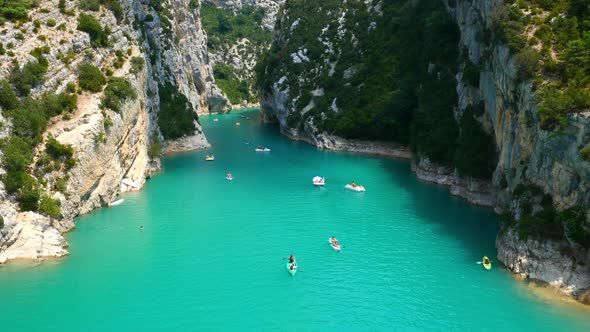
158;83;198;139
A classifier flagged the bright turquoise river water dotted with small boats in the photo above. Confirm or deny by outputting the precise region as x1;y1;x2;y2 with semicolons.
0;112;590;331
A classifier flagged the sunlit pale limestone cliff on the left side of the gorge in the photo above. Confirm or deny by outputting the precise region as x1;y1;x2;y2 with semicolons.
0;0;220;263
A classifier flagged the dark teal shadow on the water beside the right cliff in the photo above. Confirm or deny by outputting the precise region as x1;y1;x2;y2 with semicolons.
381;160;499;259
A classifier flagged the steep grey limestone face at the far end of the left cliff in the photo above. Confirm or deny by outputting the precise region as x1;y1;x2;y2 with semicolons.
134;0;231;115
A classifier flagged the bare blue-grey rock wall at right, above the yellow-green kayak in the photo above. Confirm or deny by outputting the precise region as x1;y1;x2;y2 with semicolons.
450;1;590;298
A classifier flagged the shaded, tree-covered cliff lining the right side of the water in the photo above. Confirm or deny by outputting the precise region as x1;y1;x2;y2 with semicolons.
259;0;590;299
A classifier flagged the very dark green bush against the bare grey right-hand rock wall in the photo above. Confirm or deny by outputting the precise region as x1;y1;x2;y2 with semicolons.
455;111;496;180
